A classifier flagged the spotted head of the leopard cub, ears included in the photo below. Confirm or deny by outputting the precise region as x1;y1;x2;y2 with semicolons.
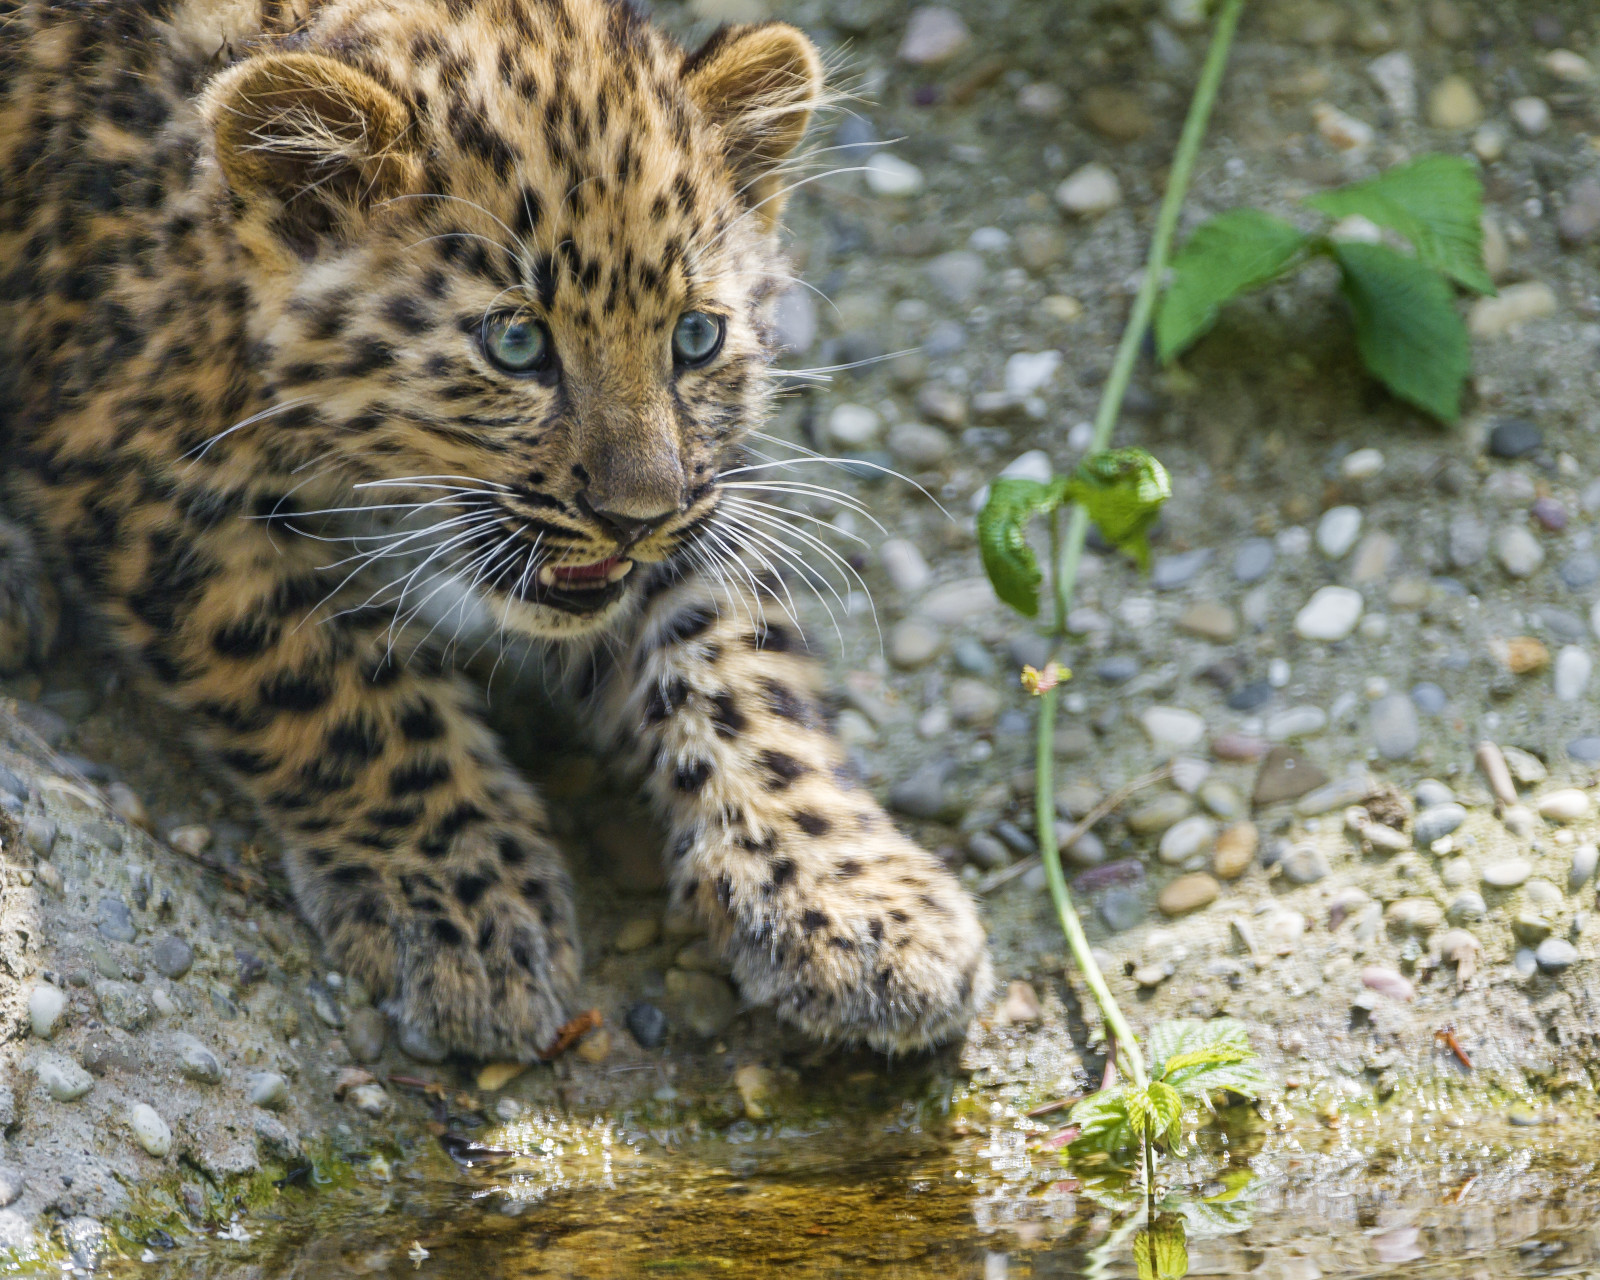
203;0;822;635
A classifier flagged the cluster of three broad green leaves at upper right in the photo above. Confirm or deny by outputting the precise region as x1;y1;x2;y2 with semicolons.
1155;155;1494;422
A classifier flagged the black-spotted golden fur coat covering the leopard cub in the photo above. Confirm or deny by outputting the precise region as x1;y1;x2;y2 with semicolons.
0;0;990;1058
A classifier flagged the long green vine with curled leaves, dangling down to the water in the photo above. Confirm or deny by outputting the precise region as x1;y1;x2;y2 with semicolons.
978;0;1261;1195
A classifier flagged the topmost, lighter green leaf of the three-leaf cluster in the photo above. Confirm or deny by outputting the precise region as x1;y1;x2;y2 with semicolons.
1306;155;1494;293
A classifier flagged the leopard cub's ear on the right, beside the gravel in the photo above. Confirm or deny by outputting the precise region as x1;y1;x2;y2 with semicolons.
683;22;824;227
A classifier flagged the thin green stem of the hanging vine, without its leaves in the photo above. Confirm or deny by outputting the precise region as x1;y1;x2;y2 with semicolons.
1034;0;1245;1120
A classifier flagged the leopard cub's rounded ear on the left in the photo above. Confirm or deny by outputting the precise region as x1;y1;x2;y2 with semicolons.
203;53;421;235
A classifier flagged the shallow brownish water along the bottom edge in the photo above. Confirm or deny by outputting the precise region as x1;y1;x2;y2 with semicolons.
40;1082;1600;1280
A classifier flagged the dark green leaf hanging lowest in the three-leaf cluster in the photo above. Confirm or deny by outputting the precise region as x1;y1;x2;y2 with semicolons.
1333;242;1472;422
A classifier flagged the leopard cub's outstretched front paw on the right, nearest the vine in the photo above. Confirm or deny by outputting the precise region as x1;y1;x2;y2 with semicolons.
678;814;994;1053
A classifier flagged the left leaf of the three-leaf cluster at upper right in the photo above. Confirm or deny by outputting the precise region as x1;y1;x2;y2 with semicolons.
1155;210;1306;365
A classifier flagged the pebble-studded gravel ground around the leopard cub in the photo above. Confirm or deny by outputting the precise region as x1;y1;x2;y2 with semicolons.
0;0;1600;1267
